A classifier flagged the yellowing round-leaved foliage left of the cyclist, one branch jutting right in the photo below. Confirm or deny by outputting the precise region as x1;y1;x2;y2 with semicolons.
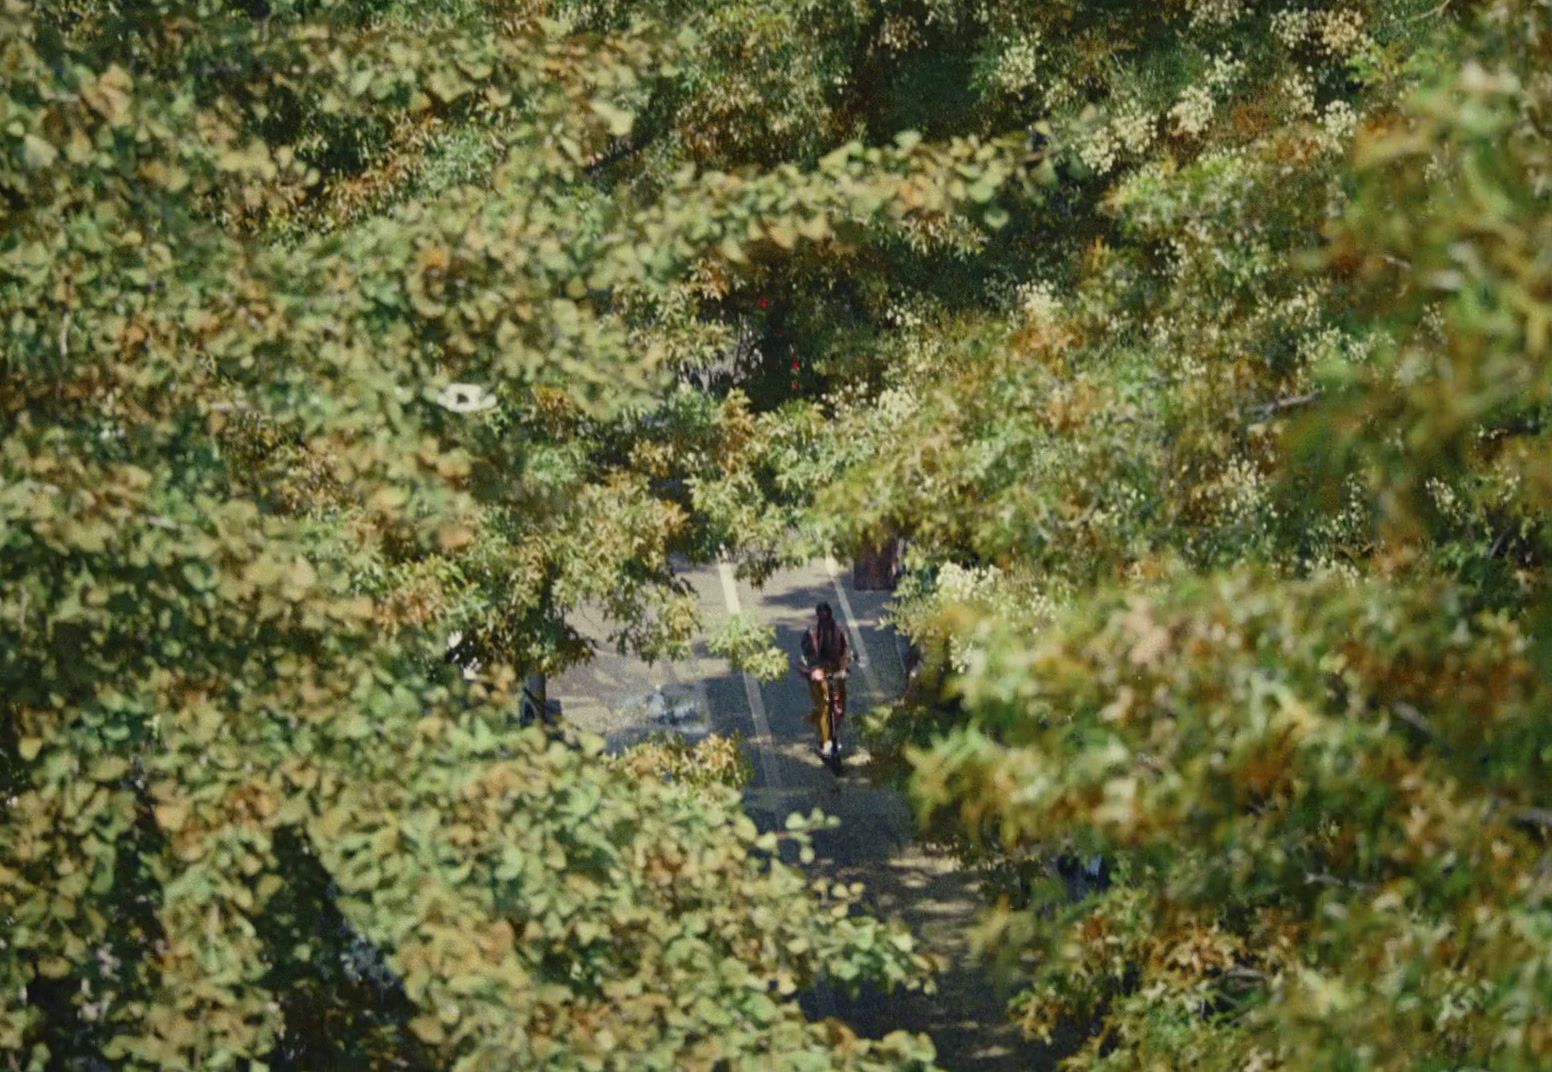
0;0;1030;1069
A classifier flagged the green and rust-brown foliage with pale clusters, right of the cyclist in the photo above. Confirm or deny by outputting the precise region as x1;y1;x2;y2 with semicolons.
741;3;1552;1069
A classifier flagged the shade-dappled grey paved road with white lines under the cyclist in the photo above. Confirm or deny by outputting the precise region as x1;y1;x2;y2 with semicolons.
549;562;1051;1072
